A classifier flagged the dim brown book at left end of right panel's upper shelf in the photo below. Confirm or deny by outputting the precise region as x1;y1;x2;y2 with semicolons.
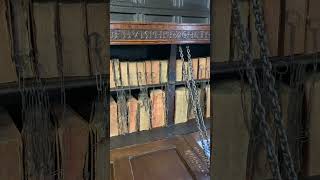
211;0;232;62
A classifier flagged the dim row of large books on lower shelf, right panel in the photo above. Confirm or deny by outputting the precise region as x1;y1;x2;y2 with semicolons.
211;74;320;180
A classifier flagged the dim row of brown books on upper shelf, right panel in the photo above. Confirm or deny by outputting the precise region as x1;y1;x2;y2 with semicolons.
211;0;320;62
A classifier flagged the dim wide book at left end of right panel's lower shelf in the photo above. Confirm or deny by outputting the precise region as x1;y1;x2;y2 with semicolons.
211;81;251;180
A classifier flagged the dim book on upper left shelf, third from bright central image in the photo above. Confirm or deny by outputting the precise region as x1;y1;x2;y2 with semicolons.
33;2;62;78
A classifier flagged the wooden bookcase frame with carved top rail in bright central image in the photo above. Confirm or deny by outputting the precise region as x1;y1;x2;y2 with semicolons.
110;22;210;149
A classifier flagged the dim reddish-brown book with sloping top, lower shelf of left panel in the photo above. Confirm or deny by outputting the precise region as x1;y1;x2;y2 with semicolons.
54;106;89;180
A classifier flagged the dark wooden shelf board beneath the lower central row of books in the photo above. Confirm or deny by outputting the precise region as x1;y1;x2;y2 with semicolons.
110;116;211;149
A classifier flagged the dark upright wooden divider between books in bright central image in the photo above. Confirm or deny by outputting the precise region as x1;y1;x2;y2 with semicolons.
167;44;177;126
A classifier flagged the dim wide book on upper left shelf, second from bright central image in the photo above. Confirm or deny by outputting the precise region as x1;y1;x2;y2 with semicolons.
59;3;90;76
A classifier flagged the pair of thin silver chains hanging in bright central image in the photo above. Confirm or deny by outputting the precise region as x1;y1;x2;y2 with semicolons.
179;46;210;167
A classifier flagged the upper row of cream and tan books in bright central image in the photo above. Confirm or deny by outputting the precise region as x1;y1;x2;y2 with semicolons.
110;57;210;88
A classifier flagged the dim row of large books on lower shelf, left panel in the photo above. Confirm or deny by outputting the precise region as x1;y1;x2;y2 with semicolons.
0;106;109;180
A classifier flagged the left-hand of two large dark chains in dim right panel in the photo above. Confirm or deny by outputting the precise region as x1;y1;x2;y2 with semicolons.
232;0;282;180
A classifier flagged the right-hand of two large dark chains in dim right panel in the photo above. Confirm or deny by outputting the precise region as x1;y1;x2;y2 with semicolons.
252;0;298;180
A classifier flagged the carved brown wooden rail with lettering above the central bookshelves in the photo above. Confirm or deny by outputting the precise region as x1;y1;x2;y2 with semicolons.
110;22;210;45
